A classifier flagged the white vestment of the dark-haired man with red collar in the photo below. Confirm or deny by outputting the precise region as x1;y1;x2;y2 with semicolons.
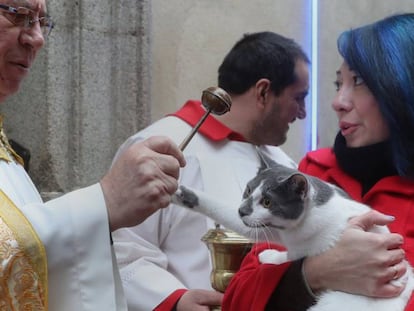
113;116;295;311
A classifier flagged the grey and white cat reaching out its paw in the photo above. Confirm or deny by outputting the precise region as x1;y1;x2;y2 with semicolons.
173;155;414;311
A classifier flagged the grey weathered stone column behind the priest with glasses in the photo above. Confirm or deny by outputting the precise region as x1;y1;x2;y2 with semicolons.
1;0;151;199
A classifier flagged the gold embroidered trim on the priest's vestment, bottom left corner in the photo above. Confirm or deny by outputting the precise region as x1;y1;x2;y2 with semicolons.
0;190;48;311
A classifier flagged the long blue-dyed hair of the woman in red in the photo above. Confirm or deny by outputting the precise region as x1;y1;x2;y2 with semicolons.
337;13;414;178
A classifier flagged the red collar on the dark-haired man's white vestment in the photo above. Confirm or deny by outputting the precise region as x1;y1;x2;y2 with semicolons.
170;100;246;142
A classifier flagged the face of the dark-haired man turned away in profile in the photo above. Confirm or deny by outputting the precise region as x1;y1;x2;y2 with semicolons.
254;60;309;146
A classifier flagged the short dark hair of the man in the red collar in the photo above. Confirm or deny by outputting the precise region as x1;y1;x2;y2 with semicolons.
218;31;310;95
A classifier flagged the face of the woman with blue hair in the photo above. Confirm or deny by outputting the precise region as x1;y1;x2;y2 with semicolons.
332;62;389;148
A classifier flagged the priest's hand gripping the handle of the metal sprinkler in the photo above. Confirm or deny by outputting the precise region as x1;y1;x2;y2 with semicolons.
101;136;185;231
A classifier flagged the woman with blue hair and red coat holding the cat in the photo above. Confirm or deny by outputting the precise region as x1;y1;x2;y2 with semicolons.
223;13;414;311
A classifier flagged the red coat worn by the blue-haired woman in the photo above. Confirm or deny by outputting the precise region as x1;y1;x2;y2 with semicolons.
222;148;414;311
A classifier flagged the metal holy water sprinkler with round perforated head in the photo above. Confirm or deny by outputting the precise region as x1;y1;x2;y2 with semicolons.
179;86;231;151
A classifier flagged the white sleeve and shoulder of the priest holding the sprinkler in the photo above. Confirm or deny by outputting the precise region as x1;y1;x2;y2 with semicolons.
0;160;127;311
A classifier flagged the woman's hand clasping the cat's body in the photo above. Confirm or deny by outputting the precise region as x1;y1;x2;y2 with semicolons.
304;212;407;298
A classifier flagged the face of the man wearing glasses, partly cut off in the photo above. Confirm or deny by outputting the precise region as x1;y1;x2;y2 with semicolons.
0;0;46;101
